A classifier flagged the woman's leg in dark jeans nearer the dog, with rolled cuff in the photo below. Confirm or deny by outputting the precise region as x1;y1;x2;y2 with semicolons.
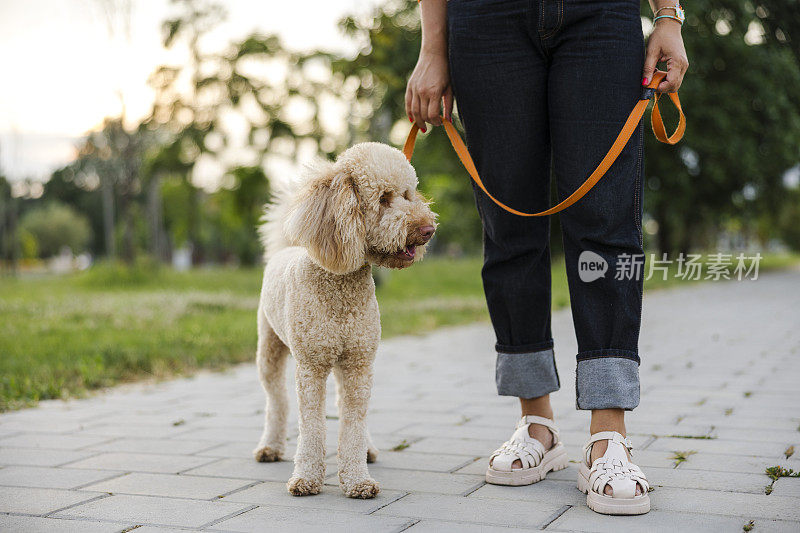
448;0;559;404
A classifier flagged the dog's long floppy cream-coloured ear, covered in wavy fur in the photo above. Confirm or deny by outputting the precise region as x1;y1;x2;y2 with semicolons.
285;165;366;274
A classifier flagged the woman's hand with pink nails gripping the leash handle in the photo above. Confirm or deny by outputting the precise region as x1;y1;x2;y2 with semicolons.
642;19;689;93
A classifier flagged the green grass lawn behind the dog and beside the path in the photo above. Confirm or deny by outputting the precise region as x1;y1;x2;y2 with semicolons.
0;251;797;411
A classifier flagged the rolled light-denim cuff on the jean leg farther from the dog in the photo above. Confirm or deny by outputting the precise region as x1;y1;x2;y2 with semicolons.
575;350;639;411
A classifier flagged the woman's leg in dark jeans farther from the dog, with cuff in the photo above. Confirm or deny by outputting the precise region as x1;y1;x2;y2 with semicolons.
544;0;644;412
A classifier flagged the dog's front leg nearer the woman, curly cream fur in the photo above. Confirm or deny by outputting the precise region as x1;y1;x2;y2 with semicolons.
336;363;380;498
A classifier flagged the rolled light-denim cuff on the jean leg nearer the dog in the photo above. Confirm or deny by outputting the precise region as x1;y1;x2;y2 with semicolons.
495;348;561;398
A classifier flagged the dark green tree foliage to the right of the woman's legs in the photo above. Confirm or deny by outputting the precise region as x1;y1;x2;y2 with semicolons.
643;0;800;252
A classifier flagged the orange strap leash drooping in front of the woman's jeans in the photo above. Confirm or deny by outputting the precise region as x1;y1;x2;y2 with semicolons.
403;70;686;217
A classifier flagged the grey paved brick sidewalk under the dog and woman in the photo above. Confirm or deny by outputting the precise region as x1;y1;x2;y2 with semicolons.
0;271;800;533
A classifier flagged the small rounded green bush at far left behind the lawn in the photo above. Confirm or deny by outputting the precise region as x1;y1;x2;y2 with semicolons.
20;202;92;257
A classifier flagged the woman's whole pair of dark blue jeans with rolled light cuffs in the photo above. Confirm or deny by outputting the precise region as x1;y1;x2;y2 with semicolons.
447;0;644;409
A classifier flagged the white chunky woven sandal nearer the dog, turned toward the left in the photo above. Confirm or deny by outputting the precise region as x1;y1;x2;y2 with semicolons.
486;415;568;486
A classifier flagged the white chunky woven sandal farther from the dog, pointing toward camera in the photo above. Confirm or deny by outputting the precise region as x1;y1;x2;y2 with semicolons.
578;431;650;515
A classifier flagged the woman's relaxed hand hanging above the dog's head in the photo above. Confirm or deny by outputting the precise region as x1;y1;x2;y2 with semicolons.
406;49;453;132
